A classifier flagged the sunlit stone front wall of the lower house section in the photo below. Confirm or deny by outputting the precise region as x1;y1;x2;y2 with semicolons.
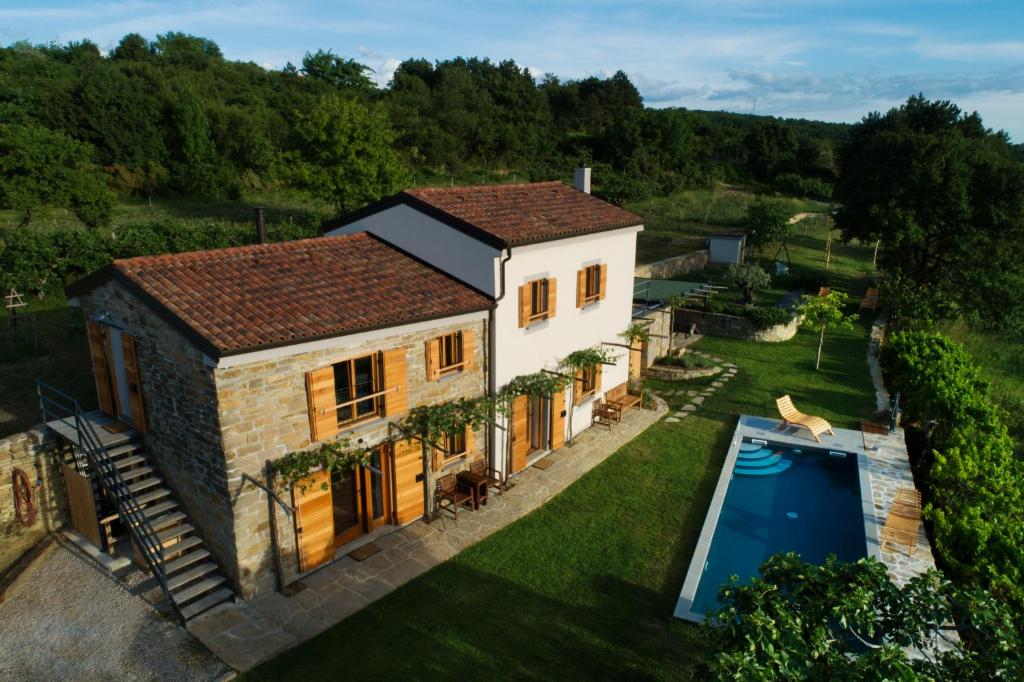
215;314;487;597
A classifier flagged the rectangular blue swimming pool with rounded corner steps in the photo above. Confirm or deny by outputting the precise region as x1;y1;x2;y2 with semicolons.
676;418;874;621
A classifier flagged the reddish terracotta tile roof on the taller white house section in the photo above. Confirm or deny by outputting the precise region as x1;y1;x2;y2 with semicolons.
399;181;643;246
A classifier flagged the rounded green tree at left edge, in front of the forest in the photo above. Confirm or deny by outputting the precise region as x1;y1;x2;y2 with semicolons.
0;124;114;226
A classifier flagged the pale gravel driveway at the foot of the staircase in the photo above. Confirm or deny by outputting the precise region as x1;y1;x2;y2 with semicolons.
0;541;228;680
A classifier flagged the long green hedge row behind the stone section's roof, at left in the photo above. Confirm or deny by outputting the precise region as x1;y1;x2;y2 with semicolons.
0;221;316;294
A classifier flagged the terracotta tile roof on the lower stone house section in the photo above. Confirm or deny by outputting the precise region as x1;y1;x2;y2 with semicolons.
84;232;492;355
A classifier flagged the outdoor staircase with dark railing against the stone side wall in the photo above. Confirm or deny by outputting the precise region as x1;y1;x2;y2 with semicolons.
36;380;234;624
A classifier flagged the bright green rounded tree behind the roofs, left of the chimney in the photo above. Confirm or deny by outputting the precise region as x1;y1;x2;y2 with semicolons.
292;94;408;212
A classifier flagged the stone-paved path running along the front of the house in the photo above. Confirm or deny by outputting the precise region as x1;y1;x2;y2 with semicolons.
188;397;668;671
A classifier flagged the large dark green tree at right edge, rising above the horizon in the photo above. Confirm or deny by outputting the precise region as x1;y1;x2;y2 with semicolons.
836;95;1024;329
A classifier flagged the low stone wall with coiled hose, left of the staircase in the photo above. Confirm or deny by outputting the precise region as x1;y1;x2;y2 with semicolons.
0;424;68;571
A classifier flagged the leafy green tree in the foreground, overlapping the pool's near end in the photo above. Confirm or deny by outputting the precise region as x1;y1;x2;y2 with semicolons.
702;553;1024;680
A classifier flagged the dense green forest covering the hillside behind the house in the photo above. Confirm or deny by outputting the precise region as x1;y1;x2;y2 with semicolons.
0;33;848;225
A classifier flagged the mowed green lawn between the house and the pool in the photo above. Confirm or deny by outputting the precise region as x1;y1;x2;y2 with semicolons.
245;235;873;681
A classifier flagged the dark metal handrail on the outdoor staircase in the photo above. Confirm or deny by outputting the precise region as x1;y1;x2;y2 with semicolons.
36;379;185;623
